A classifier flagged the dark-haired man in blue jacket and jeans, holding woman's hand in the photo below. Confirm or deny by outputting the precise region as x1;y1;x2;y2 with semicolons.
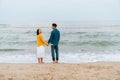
48;23;60;63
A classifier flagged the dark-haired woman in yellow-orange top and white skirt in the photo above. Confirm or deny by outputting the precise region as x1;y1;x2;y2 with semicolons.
37;29;48;64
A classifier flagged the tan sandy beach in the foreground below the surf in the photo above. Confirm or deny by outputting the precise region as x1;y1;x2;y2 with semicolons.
0;62;120;80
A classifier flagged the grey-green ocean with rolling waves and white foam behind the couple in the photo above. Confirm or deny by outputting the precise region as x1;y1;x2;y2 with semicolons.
0;23;120;63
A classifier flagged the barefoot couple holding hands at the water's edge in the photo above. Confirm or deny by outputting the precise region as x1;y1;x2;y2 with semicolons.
37;23;60;64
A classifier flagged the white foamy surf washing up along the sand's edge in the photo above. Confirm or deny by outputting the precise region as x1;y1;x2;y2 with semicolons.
0;51;120;63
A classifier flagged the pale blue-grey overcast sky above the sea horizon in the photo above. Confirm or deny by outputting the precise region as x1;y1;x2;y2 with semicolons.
0;0;120;23
